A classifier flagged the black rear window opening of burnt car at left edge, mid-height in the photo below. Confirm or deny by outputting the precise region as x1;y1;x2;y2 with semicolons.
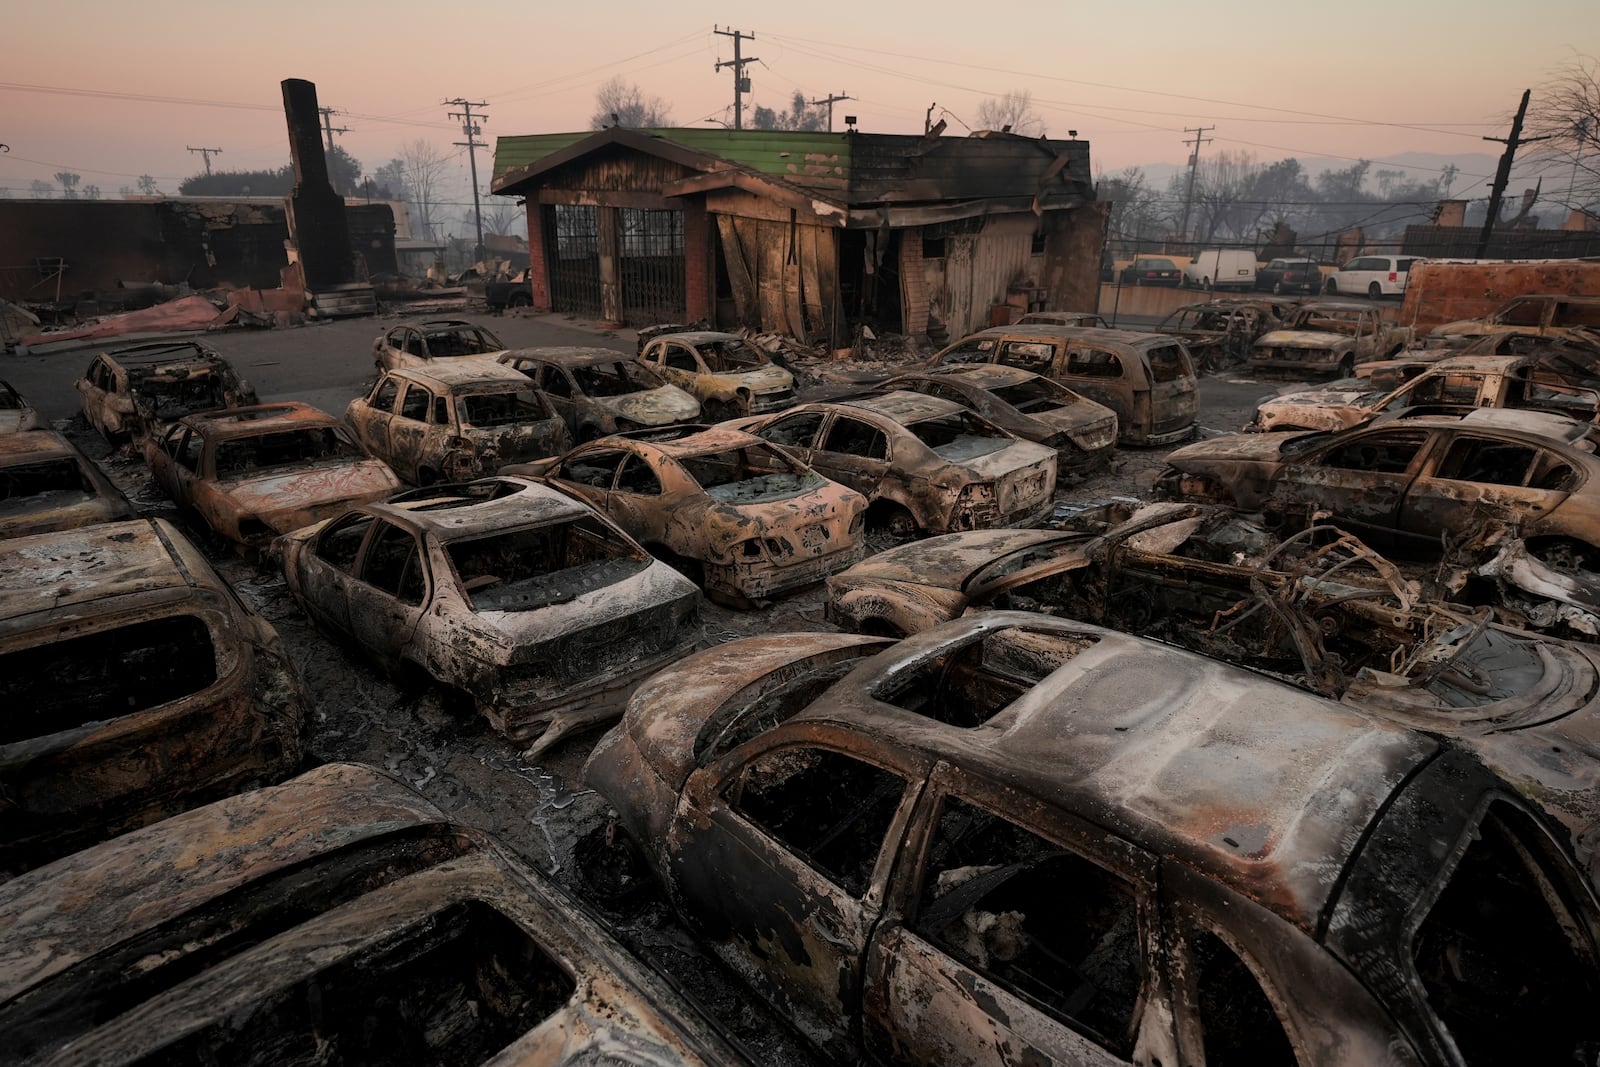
0;614;218;744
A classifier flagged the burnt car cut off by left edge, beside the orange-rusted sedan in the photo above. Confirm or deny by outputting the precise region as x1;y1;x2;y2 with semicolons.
0;430;134;537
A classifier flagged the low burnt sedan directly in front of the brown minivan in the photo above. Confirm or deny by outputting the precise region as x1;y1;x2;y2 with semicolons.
882;363;1117;470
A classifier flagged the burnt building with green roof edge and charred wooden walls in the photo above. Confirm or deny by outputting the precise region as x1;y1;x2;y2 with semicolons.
493;128;1104;347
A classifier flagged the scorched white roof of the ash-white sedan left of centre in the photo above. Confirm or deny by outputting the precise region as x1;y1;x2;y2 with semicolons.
360;475;590;541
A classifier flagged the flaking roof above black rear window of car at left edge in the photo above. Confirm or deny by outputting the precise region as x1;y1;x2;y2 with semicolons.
0;518;216;621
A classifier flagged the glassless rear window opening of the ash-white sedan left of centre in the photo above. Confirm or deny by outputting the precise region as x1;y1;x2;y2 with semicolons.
445;518;650;611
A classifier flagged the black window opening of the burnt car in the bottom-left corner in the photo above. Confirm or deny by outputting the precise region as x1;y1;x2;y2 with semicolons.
145;901;578;1067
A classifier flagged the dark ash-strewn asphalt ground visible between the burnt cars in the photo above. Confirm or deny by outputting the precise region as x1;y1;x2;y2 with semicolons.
0;303;1274;1064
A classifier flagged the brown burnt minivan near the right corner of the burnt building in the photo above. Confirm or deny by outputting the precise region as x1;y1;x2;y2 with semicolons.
925;326;1200;445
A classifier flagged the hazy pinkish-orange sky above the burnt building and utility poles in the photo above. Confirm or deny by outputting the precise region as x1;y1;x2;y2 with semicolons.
0;0;1600;207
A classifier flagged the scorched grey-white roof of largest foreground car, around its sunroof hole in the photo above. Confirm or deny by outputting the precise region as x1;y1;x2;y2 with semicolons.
789;611;1440;931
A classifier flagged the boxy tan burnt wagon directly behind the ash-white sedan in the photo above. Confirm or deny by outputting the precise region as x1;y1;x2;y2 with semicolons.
344;360;566;485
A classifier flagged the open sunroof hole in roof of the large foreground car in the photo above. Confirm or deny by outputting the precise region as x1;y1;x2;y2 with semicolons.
872;627;1099;728
